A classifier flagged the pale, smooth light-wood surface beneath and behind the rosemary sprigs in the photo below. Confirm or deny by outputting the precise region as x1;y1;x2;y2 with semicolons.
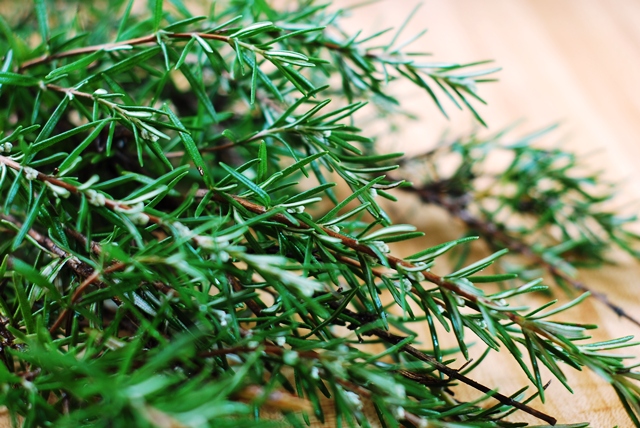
335;0;640;428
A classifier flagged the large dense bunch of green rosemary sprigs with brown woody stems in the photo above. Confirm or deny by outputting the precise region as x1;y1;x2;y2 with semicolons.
0;0;640;427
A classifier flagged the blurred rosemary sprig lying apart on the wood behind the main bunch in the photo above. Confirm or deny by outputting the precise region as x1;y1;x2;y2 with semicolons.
396;126;640;326
